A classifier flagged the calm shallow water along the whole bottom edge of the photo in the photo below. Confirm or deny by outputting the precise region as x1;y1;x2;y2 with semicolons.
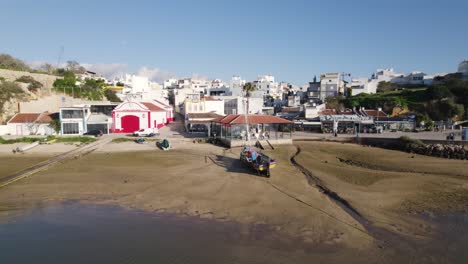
0;202;468;264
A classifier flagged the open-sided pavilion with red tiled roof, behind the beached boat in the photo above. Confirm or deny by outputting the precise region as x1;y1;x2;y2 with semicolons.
210;115;294;146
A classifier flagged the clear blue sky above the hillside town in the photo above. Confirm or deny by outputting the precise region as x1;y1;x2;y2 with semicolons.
0;0;468;85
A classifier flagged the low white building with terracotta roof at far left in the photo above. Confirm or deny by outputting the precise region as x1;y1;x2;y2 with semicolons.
6;113;55;136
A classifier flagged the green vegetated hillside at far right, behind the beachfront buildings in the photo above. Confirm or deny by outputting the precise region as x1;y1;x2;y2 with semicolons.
327;74;468;125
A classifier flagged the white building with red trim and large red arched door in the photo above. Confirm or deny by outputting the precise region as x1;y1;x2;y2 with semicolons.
112;100;174;133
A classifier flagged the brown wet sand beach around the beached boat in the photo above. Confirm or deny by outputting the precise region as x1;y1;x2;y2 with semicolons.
0;142;468;263
